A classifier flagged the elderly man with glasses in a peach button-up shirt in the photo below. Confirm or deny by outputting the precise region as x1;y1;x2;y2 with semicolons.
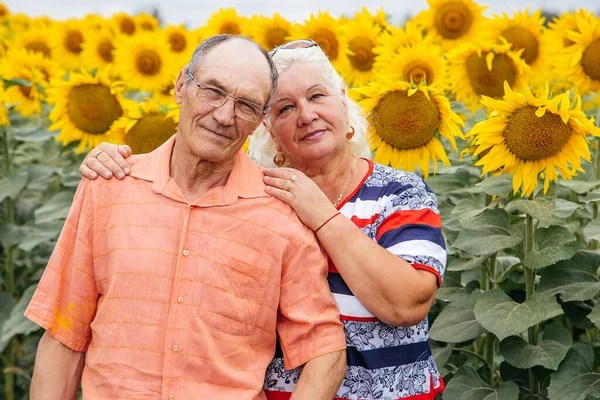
26;35;345;400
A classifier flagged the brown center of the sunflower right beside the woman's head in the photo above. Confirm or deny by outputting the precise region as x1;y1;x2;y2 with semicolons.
373;91;440;150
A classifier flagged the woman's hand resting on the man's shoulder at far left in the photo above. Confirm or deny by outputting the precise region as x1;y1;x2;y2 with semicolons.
79;142;131;179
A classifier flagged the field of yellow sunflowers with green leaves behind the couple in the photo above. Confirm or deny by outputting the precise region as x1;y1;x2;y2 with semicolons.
0;0;600;400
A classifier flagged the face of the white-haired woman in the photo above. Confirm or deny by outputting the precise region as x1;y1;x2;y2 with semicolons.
268;63;348;169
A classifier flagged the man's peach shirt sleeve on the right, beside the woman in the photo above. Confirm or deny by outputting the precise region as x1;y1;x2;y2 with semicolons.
277;227;346;369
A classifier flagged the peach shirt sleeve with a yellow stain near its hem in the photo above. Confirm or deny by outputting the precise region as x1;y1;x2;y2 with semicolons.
25;178;98;352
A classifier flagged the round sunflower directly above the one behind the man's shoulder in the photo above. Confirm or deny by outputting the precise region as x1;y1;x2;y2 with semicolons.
114;32;178;92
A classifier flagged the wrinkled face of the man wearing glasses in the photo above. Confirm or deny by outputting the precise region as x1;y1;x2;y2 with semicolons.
175;40;271;163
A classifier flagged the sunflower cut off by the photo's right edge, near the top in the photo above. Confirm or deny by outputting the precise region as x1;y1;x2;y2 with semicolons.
556;16;600;93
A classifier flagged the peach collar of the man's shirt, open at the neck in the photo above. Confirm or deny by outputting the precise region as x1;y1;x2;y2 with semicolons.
130;134;270;206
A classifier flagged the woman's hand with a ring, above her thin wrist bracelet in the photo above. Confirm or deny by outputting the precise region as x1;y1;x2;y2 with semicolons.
263;168;337;230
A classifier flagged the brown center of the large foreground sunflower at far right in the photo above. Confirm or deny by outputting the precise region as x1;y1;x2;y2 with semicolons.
503;106;571;161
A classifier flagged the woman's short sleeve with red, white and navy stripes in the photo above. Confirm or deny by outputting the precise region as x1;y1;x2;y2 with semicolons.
376;171;446;286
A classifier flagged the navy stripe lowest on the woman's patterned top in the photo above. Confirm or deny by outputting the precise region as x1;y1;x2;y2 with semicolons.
275;338;431;369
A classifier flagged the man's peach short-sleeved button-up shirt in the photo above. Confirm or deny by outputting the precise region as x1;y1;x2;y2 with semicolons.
25;135;345;400
